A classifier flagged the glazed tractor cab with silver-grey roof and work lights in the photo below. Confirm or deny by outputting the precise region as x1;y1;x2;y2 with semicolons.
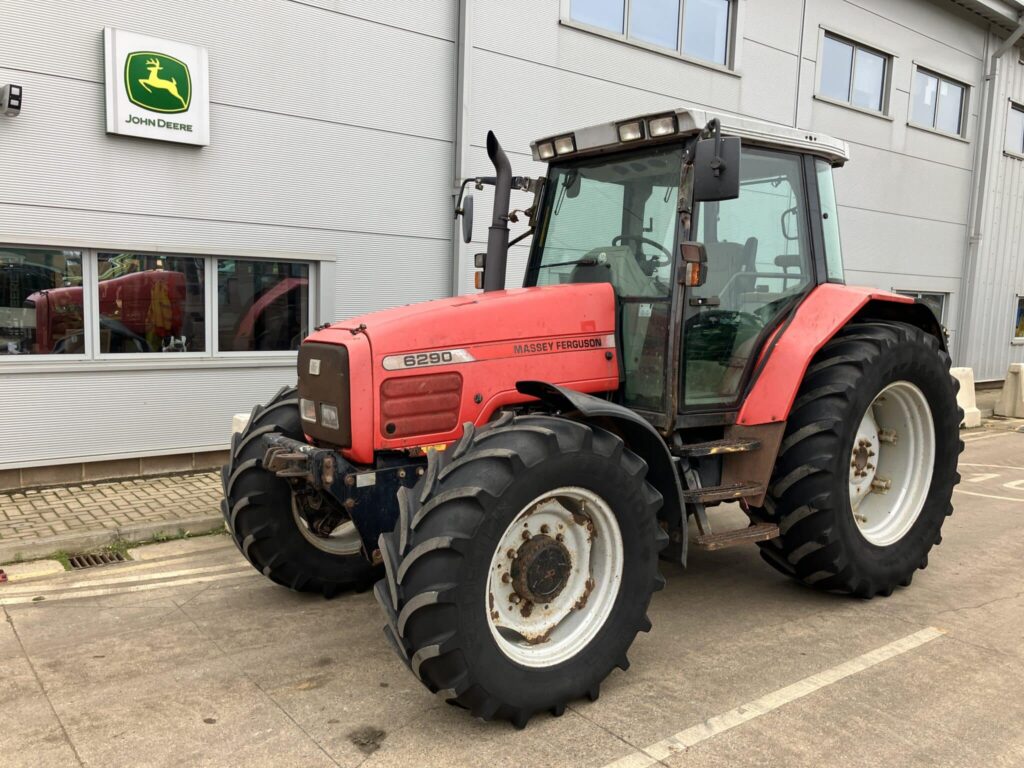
524;110;847;428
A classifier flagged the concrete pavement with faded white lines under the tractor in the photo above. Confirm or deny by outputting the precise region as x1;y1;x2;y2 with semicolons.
0;430;1024;768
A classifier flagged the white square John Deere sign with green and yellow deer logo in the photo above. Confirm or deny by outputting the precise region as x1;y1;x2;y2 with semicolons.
103;29;210;144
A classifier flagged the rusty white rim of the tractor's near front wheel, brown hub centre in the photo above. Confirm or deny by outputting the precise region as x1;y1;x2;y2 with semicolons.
485;486;624;668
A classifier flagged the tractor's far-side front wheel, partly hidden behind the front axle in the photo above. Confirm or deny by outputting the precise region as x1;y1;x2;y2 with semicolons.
220;387;377;597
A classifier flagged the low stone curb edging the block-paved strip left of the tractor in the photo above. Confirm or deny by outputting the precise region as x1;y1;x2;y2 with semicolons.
0;513;224;563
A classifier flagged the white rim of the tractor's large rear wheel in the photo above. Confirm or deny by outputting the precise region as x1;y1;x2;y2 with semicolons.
849;381;935;547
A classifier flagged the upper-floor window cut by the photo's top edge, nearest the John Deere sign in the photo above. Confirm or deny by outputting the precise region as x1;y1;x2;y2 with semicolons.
569;0;735;67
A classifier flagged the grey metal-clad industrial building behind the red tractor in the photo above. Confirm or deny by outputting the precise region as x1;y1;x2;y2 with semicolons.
0;0;1024;487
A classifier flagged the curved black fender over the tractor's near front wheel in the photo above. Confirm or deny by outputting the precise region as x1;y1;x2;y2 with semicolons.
516;381;688;565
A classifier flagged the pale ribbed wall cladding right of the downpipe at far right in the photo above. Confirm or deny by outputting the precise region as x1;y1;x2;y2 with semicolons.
967;50;1024;381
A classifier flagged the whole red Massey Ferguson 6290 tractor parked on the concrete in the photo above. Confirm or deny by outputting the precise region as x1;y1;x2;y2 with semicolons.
222;109;962;727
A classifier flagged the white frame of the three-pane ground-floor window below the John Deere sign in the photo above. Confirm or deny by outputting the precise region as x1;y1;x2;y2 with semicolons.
0;240;317;373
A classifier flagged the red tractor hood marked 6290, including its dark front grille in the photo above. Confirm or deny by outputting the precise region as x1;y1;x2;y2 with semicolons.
298;283;618;465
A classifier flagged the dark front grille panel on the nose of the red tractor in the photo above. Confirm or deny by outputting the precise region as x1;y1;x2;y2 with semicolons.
298;342;352;447
